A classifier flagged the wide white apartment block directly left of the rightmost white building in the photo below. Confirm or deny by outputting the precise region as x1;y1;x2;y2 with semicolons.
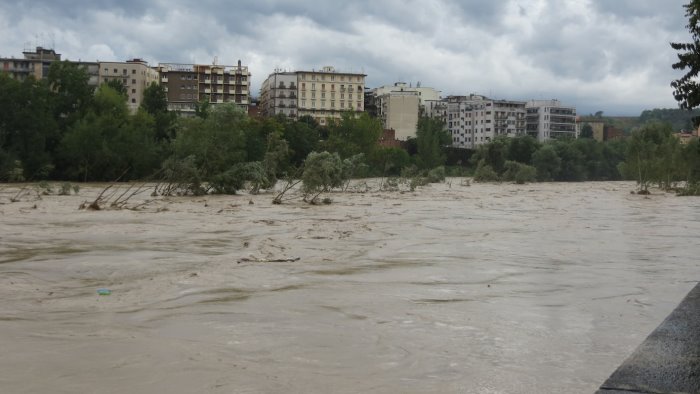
442;94;525;149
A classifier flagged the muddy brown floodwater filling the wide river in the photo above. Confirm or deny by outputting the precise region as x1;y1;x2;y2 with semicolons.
0;179;700;393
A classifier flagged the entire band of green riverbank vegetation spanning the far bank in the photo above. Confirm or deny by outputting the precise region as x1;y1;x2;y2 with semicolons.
0;62;700;196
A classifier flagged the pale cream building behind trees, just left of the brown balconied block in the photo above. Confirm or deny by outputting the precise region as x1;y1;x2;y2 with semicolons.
98;59;159;113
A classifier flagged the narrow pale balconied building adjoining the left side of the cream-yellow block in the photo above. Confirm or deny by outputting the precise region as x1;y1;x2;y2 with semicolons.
260;70;298;118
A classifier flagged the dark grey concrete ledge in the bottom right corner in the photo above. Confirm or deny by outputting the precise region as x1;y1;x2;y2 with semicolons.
597;284;700;394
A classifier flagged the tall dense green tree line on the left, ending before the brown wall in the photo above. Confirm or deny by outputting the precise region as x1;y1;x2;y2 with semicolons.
0;62;446;192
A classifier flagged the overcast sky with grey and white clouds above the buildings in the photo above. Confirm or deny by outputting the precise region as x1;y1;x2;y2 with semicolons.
0;0;690;115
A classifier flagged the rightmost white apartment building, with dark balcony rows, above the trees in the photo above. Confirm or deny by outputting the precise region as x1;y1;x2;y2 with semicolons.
525;100;578;142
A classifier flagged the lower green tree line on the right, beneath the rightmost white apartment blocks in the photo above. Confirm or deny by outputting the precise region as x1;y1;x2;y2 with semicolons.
471;122;700;195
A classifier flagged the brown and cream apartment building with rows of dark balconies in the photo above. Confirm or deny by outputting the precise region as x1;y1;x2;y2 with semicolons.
157;60;251;116
